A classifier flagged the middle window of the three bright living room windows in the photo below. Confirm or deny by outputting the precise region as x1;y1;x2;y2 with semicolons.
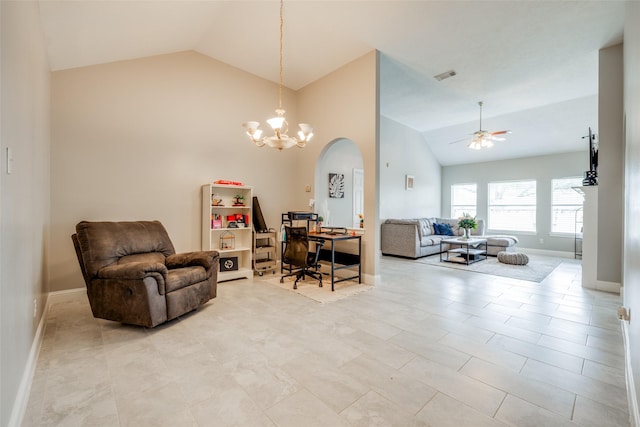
488;180;536;233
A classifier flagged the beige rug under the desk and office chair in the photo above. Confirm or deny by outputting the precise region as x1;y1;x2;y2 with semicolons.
254;275;373;303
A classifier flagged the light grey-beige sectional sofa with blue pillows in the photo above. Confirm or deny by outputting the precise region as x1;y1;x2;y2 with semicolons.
380;218;518;259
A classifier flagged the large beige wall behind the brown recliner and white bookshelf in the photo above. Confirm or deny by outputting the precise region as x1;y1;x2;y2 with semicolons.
51;52;299;291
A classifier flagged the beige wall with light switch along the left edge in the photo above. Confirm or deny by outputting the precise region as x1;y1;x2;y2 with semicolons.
0;1;50;426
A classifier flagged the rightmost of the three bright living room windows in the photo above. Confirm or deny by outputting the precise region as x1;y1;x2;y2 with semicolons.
551;177;582;234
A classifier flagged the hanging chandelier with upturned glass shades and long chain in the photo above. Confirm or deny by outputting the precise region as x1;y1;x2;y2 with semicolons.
242;0;313;151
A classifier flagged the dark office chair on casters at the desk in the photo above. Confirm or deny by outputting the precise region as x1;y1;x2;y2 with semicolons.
280;226;324;289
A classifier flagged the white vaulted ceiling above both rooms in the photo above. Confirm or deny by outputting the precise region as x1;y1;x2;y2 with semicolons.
39;0;624;165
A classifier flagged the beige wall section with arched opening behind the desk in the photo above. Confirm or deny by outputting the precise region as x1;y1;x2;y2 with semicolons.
293;51;379;282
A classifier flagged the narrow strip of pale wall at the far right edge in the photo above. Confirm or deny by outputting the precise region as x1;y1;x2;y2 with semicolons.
622;2;640;414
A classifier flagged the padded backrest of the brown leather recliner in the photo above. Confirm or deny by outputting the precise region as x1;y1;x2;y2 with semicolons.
76;221;176;280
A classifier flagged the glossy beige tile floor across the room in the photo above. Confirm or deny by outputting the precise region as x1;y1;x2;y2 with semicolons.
24;257;629;427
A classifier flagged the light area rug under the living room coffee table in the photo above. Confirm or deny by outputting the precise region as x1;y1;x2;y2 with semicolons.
416;255;563;283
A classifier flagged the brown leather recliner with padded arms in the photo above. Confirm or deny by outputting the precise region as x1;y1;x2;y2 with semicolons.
71;221;219;327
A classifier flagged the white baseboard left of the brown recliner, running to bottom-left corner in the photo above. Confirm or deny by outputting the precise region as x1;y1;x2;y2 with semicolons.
9;288;86;427
